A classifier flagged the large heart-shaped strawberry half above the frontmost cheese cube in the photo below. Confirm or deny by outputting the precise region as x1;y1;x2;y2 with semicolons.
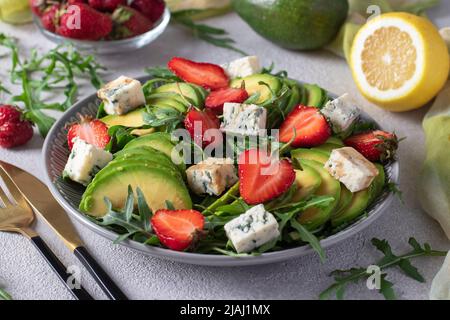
238;149;295;204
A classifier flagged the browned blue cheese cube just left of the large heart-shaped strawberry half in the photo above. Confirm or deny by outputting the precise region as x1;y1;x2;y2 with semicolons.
186;158;238;196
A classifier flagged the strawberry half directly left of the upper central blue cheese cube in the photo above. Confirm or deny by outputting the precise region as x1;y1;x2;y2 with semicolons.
184;108;222;147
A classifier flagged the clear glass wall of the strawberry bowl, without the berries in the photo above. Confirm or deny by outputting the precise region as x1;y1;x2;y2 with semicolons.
33;8;170;54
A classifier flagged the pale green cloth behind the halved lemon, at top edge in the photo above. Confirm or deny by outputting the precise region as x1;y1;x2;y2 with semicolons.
327;0;440;60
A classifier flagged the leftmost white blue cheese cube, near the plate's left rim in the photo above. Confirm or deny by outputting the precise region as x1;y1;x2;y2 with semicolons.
63;138;113;186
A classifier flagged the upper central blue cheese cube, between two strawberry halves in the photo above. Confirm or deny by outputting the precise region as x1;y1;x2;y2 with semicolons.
220;102;267;136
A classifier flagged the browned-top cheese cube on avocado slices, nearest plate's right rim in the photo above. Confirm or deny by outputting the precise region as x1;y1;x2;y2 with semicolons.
324;147;379;192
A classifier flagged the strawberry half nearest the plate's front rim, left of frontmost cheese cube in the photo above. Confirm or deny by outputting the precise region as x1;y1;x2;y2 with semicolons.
151;210;205;251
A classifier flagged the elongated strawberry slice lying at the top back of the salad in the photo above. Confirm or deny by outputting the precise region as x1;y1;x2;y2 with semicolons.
168;57;230;90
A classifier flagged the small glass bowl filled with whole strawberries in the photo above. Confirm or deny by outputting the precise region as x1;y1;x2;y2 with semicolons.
30;0;170;54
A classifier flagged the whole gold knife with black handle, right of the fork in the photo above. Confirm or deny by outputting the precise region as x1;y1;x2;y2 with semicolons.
0;160;127;300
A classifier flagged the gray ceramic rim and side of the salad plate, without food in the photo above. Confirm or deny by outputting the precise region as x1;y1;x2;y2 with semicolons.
43;77;399;267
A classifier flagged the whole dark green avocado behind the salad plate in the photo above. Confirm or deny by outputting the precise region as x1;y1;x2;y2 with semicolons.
232;0;349;50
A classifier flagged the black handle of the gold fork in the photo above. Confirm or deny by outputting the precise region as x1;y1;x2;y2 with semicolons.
30;236;94;300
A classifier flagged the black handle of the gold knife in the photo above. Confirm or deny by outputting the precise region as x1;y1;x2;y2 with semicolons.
73;246;128;300
